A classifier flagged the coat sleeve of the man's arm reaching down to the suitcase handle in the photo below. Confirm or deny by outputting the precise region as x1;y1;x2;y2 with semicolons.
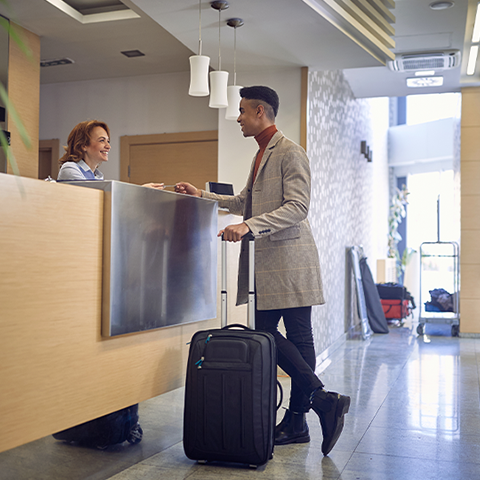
245;145;311;236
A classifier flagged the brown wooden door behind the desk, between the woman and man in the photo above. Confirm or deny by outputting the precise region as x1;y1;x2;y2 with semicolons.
120;131;218;189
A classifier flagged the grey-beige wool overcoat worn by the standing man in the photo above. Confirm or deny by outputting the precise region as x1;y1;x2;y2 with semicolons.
202;131;325;310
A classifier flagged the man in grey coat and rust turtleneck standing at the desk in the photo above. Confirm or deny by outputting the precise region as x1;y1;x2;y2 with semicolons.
176;86;350;455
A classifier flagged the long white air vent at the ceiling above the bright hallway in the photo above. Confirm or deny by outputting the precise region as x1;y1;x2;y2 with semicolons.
387;50;460;72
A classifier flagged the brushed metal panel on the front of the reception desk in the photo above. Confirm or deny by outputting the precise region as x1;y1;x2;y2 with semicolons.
67;181;218;336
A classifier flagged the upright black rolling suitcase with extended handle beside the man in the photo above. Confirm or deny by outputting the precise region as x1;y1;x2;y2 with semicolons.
183;237;277;467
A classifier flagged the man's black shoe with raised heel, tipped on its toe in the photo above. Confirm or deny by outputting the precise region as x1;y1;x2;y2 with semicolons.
312;389;350;455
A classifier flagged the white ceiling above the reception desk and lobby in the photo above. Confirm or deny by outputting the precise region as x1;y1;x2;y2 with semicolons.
0;0;480;97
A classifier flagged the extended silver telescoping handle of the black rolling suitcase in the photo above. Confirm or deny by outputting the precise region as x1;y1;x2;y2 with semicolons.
221;232;255;330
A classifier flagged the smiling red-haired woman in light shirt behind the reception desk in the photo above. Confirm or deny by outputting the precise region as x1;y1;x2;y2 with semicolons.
57;120;164;190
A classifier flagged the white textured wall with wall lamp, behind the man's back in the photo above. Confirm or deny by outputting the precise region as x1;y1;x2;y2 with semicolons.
307;71;389;353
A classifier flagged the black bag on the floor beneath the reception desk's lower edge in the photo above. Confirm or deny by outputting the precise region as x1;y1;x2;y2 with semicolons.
53;403;143;449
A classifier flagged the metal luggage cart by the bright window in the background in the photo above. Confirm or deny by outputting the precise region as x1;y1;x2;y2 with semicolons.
417;241;460;337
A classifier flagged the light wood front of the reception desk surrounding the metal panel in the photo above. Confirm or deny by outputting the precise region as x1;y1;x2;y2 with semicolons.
0;174;246;451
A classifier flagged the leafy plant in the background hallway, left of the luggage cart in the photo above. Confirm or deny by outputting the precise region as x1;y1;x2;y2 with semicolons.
387;185;416;283
